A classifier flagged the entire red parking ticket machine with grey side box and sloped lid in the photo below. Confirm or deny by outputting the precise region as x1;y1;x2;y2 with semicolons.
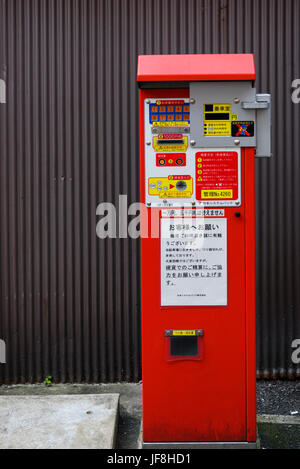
137;54;271;448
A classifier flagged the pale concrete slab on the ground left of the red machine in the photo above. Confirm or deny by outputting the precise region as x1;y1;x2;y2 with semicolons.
0;394;119;449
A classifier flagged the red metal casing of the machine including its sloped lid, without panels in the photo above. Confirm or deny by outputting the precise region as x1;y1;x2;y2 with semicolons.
138;54;256;447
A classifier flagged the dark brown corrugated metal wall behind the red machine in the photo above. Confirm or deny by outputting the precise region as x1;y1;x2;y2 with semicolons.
0;0;300;383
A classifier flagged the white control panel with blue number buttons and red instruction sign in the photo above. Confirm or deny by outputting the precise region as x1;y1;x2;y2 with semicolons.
144;98;241;208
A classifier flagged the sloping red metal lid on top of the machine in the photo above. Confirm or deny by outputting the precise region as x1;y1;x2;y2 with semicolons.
137;54;255;82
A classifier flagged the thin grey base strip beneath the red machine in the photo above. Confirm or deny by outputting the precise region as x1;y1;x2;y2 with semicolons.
142;441;257;449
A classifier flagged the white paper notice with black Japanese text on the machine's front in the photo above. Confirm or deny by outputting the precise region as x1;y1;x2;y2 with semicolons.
161;218;227;306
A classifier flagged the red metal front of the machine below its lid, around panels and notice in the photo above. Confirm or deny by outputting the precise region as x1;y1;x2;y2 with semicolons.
140;90;255;442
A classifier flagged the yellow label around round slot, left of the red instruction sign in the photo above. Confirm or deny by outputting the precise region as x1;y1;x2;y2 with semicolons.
148;176;193;199
